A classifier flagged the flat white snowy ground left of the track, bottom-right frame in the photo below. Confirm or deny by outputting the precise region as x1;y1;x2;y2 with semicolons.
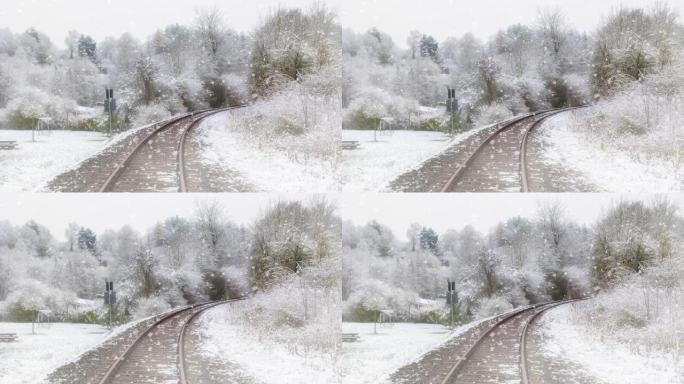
340;323;470;384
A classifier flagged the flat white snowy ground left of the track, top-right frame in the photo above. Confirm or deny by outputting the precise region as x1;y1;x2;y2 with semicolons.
339;125;491;192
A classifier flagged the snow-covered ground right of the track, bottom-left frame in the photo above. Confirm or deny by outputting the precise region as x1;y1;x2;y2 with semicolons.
198;306;336;384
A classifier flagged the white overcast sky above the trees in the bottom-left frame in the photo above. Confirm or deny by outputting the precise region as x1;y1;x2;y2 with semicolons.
0;193;316;239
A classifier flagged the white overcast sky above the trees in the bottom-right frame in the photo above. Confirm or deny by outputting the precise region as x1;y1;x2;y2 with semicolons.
339;193;684;238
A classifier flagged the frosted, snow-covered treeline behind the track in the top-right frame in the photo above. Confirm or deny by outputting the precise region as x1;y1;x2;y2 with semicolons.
343;4;684;130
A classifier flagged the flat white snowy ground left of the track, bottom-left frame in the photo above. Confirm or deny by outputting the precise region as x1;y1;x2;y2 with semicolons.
0;323;110;384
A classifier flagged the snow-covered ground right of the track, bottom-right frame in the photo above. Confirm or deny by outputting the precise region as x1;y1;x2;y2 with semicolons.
538;306;684;384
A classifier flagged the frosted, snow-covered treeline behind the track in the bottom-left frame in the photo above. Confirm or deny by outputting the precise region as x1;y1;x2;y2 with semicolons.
0;201;339;322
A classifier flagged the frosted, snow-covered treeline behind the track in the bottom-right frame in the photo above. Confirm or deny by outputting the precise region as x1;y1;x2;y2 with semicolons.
342;200;684;322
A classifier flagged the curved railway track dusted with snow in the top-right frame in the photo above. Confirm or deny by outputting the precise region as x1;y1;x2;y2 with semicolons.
441;107;576;192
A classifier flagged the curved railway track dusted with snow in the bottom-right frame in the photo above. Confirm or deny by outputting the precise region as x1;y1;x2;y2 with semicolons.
441;299;583;384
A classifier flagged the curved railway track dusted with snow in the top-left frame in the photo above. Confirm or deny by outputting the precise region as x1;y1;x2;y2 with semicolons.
98;107;240;192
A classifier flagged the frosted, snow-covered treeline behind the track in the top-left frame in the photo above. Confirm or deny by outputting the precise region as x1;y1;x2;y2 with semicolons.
0;6;339;133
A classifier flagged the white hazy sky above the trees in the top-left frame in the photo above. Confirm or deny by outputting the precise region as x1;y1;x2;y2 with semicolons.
0;0;326;46
